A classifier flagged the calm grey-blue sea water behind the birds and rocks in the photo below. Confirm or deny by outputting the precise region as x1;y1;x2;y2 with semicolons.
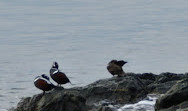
0;0;188;111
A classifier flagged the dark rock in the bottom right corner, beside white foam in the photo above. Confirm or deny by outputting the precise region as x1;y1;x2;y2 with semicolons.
155;78;188;111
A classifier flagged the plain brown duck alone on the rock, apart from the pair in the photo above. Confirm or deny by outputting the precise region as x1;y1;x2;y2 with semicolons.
107;60;128;77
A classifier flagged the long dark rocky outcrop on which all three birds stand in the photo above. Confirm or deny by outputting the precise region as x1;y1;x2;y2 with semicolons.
14;73;186;111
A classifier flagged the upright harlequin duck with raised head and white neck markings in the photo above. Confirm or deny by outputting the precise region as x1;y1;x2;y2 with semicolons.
50;62;71;86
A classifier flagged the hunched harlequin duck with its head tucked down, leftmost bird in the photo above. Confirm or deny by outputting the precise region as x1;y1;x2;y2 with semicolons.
34;74;55;95
